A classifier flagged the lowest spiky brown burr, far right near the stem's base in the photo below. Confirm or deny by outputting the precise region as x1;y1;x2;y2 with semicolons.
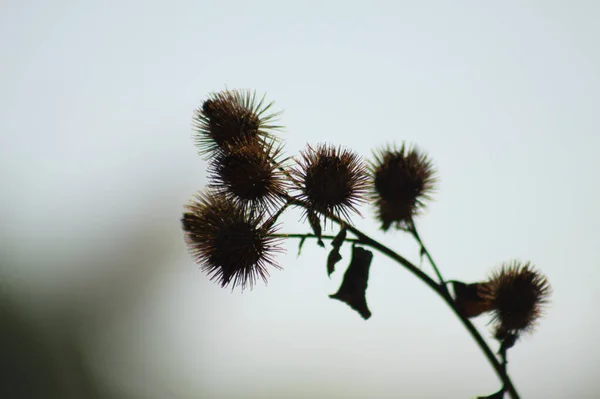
488;261;552;334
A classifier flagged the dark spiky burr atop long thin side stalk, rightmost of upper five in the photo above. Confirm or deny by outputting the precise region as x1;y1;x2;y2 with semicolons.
370;144;437;231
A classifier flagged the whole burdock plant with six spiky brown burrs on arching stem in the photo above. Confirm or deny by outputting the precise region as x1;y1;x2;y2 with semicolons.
181;90;551;399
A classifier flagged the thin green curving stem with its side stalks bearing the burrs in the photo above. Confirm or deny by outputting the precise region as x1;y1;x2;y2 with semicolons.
276;197;520;399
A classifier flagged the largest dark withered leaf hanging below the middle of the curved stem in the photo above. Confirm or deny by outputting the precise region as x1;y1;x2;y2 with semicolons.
329;246;373;320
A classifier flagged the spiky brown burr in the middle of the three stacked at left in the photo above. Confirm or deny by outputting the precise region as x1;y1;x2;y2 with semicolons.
209;140;288;212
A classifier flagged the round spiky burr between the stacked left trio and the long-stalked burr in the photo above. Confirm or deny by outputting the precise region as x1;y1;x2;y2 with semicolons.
293;144;369;223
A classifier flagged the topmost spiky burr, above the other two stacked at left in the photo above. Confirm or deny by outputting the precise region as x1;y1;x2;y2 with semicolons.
193;90;281;159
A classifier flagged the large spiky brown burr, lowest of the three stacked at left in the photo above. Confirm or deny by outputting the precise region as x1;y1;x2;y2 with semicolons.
181;192;282;290
